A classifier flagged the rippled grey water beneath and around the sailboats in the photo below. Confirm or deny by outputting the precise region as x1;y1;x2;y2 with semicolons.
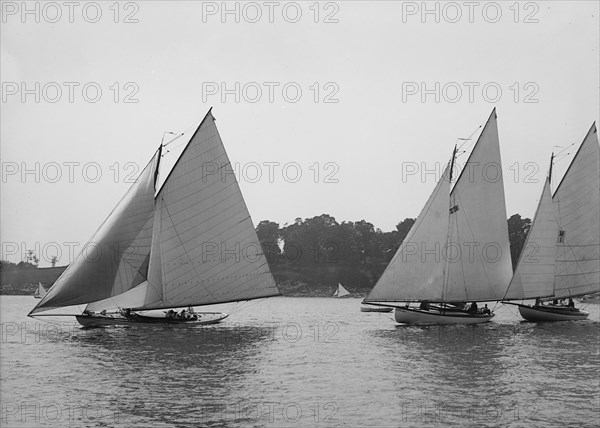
0;296;600;427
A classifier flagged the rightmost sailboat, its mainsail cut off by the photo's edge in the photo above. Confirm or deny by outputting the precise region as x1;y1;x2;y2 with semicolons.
504;123;600;321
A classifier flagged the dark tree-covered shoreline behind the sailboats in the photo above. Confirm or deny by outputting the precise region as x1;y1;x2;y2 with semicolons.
0;214;531;295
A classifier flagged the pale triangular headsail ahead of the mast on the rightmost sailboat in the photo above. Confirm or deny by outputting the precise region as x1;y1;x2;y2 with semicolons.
504;178;558;300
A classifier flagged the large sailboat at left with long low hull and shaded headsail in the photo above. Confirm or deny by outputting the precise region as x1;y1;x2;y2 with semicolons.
29;110;279;327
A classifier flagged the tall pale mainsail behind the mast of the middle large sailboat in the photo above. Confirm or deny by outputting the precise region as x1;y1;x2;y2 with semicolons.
443;110;512;302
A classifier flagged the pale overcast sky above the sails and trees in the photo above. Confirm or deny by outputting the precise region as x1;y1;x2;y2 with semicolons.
0;1;600;266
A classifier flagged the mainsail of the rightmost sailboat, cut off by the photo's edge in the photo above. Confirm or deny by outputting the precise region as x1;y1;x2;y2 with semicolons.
552;123;600;298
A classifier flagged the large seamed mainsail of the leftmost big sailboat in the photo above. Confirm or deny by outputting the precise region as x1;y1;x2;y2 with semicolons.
138;108;279;309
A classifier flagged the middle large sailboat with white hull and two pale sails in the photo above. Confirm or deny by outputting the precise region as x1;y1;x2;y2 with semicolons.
363;109;512;324
